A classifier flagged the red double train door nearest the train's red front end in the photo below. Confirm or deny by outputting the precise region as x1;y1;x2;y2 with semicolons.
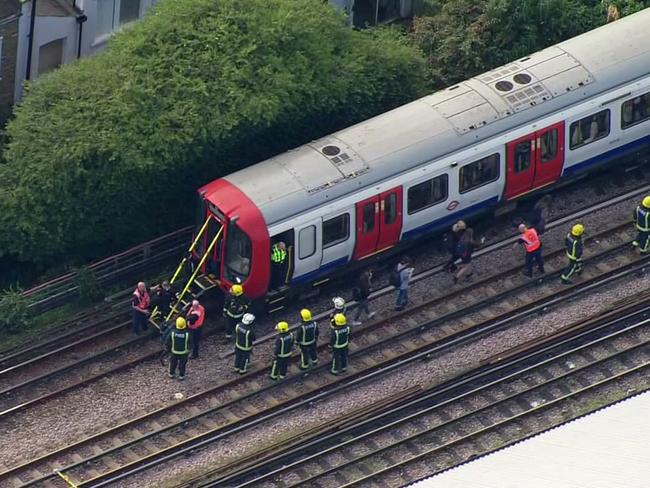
354;186;402;259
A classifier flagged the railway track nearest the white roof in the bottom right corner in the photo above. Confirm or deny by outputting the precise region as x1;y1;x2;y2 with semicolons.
199;296;650;488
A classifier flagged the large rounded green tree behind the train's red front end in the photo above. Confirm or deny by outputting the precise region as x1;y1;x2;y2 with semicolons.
0;0;426;270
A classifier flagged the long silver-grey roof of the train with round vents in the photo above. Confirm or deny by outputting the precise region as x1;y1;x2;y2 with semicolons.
215;9;650;226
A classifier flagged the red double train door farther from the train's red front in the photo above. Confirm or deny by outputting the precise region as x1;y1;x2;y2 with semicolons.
505;122;564;199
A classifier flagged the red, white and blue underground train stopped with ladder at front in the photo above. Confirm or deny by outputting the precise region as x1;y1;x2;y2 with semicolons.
190;9;650;303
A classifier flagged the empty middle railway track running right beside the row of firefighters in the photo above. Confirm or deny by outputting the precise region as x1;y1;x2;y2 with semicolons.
0;218;648;486
